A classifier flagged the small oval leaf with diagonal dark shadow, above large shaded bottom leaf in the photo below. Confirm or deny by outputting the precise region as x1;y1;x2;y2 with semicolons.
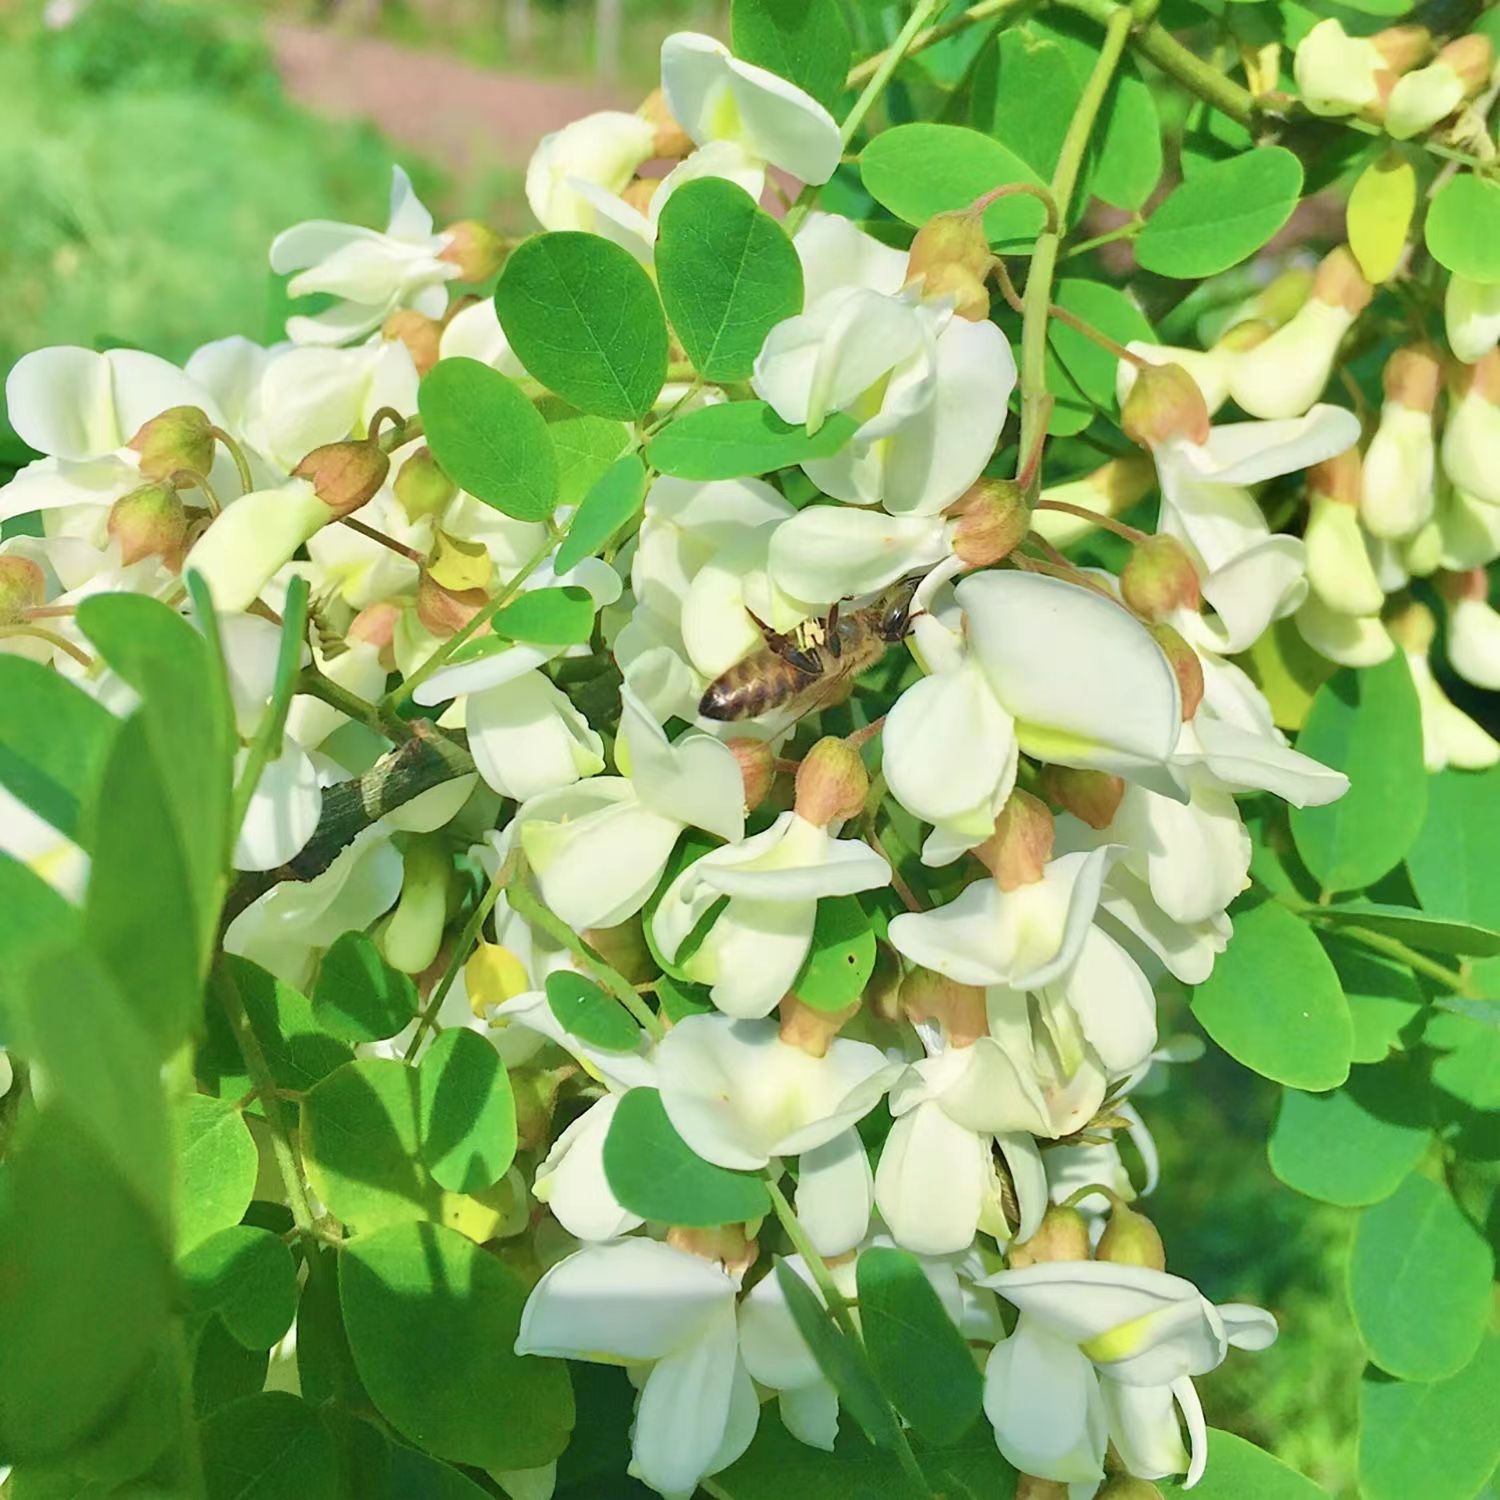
417;1026;516;1193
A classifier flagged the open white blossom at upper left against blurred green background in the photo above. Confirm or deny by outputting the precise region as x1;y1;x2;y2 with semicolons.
270;167;459;344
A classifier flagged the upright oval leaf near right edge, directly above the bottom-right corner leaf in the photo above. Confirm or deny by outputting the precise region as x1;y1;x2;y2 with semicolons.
1349;1176;1494;1380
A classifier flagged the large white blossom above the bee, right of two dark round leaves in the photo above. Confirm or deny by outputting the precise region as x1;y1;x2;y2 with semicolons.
752;215;1016;516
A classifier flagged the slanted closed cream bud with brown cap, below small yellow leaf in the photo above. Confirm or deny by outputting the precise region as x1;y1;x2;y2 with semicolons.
1229;245;1374;419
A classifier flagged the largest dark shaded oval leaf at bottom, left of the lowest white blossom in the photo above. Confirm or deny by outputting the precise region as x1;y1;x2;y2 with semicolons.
339;1224;573;1469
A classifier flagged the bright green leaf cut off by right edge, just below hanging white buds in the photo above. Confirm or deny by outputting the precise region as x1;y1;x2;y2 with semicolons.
1407;767;1500;927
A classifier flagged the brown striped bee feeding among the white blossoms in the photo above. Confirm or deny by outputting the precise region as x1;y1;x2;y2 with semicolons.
698;576;921;725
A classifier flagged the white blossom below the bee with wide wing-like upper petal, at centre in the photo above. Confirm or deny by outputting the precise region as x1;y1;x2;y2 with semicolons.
651;810;891;1019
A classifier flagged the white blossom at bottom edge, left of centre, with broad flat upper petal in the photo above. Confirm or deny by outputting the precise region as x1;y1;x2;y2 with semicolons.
516;1239;759;1497
